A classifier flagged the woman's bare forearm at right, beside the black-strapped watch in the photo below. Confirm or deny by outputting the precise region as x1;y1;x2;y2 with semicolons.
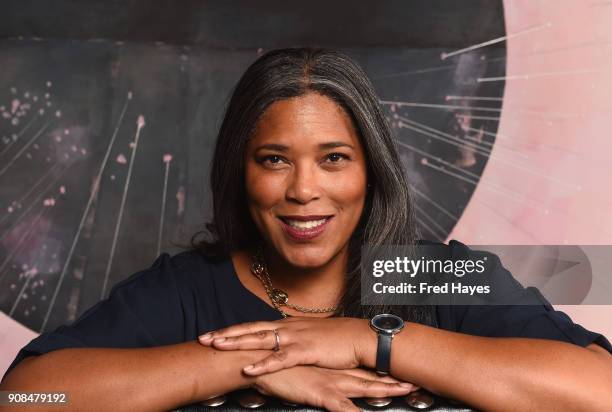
362;323;612;410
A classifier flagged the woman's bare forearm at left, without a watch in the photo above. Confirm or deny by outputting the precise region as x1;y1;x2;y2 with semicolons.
0;341;270;411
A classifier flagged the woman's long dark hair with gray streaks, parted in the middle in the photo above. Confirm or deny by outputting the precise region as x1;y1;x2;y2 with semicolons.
191;48;436;326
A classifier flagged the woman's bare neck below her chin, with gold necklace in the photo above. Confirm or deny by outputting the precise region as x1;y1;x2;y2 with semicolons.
264;246;348;308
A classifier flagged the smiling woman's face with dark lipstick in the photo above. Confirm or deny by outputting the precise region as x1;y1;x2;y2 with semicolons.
245;93;367;268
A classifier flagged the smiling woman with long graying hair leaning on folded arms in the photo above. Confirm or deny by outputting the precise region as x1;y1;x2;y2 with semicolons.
1;48;612;411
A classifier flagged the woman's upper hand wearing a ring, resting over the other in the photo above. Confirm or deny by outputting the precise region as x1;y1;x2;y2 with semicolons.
198;316;376;375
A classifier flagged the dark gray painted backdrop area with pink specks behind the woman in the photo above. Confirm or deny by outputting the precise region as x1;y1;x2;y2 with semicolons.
0;0;505;331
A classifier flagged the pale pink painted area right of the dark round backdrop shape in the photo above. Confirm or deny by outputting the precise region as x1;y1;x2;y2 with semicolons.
449;0;612;337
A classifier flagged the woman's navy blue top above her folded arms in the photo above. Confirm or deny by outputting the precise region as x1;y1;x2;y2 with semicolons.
5;240;612;382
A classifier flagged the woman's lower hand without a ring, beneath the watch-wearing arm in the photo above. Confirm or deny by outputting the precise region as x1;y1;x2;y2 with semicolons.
252;366;419;412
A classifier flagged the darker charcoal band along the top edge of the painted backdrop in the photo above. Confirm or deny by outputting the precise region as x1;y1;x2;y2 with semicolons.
0;0;504;49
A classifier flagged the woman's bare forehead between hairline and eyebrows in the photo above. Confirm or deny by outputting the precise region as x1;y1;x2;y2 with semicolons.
251;93;359;145
